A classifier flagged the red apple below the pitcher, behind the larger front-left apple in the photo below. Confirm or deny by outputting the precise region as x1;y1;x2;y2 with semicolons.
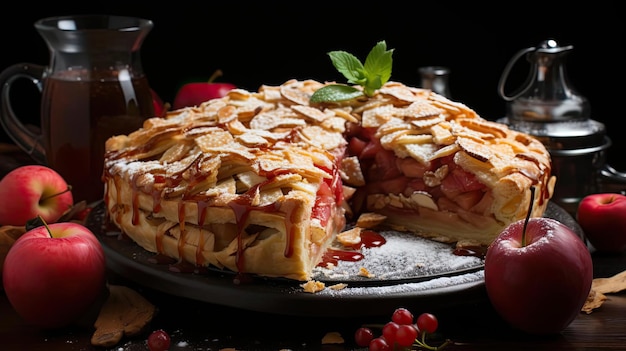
0;165;74;226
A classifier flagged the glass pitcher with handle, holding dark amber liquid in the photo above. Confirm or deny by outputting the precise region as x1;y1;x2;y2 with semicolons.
0;15;154;203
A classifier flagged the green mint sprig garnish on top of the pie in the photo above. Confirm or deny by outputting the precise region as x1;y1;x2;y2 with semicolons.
310;40;393;103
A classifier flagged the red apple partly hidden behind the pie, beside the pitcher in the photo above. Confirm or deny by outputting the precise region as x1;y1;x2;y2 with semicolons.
172;70;236;110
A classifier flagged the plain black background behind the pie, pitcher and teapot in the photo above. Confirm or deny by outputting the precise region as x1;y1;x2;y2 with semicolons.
0;0;626;170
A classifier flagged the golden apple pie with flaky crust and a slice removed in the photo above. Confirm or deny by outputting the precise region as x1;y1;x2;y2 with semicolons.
103;80;556;281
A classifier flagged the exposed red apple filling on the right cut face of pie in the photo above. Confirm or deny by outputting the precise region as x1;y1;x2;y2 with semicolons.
350;129;502;243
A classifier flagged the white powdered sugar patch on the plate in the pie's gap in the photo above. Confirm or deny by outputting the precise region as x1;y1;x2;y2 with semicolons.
314;231;484;282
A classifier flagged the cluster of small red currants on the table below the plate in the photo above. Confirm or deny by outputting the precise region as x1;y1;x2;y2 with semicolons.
354;308;452;351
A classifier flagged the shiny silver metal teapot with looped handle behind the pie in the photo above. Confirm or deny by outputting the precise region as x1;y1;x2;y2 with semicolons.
498;39;626;213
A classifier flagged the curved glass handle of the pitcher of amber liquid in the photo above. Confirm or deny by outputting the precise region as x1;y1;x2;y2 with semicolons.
0;63;46;164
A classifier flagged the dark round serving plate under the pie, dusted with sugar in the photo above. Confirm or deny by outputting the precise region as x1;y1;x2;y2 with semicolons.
86;203;583;317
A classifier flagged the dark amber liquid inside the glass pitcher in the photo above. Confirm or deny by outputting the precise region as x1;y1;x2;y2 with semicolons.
41;70;154;203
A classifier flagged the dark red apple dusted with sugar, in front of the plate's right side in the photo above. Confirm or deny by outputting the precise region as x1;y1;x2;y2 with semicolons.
485;218;593;334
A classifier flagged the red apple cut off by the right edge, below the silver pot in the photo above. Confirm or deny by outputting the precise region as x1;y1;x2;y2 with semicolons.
576;193;626;253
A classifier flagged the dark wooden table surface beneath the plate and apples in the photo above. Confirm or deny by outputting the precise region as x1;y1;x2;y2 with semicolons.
0;145;626;351
